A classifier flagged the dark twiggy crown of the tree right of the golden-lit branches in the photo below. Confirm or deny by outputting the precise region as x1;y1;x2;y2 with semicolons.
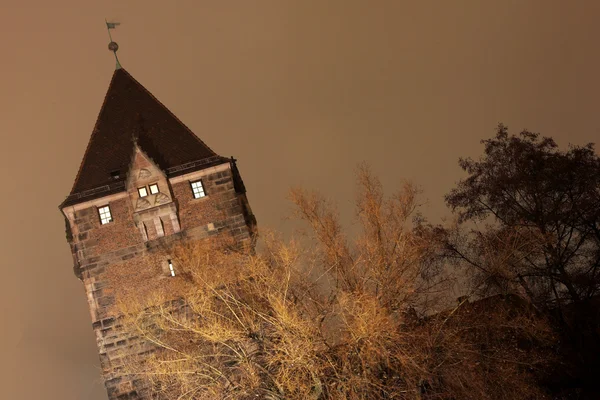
446;125;600;308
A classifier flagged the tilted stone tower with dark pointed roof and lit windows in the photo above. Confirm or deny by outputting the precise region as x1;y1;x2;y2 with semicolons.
59;67;256;400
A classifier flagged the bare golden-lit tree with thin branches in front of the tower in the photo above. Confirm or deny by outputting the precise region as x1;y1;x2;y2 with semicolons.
111;166;553;400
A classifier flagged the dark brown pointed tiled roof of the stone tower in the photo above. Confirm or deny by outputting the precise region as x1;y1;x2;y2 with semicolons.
61;68;229;208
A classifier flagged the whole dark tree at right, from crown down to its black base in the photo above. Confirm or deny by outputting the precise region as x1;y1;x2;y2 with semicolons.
438;125;600;399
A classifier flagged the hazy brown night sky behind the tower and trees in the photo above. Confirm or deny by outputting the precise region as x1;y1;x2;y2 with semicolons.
0;0;600;400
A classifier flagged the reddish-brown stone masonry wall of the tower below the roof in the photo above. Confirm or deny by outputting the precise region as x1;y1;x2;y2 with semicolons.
63;164;252;400
